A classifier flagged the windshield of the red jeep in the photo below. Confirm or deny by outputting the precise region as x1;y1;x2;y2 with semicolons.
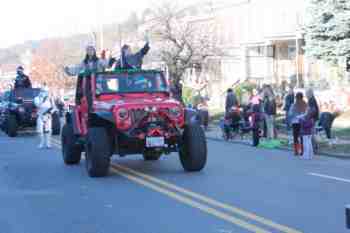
96;73;169;94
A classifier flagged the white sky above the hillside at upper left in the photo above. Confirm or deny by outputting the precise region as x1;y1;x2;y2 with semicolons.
0;0;154;48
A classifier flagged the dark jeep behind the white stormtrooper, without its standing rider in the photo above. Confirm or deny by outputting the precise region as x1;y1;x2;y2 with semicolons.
0;88;61;137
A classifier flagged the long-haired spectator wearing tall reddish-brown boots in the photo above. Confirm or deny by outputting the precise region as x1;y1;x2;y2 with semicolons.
288;92;307;156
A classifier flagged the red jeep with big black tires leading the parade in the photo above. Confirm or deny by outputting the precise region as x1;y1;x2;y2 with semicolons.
61;70;207;177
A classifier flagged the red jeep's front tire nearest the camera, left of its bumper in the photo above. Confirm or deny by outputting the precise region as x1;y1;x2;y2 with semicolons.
85;127;111;177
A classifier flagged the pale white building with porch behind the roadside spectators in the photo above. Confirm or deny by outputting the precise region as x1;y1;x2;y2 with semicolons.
141;0;346;108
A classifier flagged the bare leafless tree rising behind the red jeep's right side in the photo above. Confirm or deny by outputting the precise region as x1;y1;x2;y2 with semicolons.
146;2;221;100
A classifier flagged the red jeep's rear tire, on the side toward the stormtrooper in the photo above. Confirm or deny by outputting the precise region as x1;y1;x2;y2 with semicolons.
61;124;82;165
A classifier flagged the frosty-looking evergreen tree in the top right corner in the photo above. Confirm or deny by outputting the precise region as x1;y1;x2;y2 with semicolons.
305;0;350;64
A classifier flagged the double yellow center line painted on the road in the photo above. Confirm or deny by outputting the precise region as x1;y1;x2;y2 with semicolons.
52;138;302;233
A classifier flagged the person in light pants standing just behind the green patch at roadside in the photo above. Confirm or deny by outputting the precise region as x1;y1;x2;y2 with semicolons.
263;85;277;139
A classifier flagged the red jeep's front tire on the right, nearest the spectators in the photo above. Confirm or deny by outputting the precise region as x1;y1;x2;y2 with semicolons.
179;125;207;172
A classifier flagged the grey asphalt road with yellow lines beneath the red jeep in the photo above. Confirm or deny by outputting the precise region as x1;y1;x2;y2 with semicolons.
0;131;350;233
